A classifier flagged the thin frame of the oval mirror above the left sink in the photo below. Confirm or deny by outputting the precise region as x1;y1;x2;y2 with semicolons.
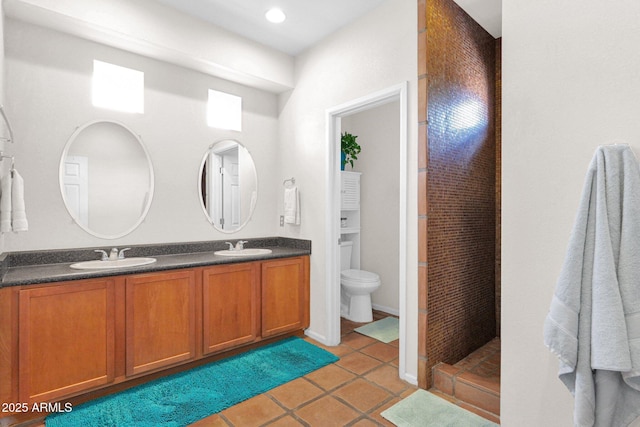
58;120;155;240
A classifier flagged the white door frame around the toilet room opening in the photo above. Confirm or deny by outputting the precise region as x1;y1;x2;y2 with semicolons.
325;81;415;382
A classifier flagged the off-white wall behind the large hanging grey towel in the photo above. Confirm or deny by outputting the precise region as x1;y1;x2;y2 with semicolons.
501;0;640;427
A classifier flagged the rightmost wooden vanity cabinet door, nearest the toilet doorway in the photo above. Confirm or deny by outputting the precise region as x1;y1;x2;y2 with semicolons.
262;257;309;337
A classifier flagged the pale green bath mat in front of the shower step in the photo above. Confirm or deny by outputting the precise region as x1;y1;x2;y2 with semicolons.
380;390;498;427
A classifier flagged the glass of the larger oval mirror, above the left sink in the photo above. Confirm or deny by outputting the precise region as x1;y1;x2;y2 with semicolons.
60;120;153;239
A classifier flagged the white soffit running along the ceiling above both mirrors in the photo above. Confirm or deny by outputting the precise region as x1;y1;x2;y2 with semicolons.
3;0;293;92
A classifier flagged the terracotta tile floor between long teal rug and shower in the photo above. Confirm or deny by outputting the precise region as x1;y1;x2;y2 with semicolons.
191;313;417;427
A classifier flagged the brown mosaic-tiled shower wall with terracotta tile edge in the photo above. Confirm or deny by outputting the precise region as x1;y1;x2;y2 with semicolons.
418;0;497;388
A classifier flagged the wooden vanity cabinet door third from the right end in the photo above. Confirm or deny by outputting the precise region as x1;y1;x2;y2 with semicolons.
125;270;196;375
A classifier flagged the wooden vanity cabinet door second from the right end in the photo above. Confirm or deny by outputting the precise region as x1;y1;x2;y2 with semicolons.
202;263;259;354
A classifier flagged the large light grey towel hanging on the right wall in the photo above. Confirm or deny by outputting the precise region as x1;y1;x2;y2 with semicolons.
544;145;640;427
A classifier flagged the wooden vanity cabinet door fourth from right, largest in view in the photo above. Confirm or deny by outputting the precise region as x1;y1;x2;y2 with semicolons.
18;279;115;402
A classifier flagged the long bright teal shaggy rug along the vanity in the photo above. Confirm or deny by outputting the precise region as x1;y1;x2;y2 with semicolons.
46;337;338;427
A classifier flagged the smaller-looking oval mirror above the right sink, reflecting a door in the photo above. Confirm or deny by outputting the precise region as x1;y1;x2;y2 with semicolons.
198;139;258;233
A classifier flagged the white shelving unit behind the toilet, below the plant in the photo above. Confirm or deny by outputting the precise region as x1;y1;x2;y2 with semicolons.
340;171;362;269
